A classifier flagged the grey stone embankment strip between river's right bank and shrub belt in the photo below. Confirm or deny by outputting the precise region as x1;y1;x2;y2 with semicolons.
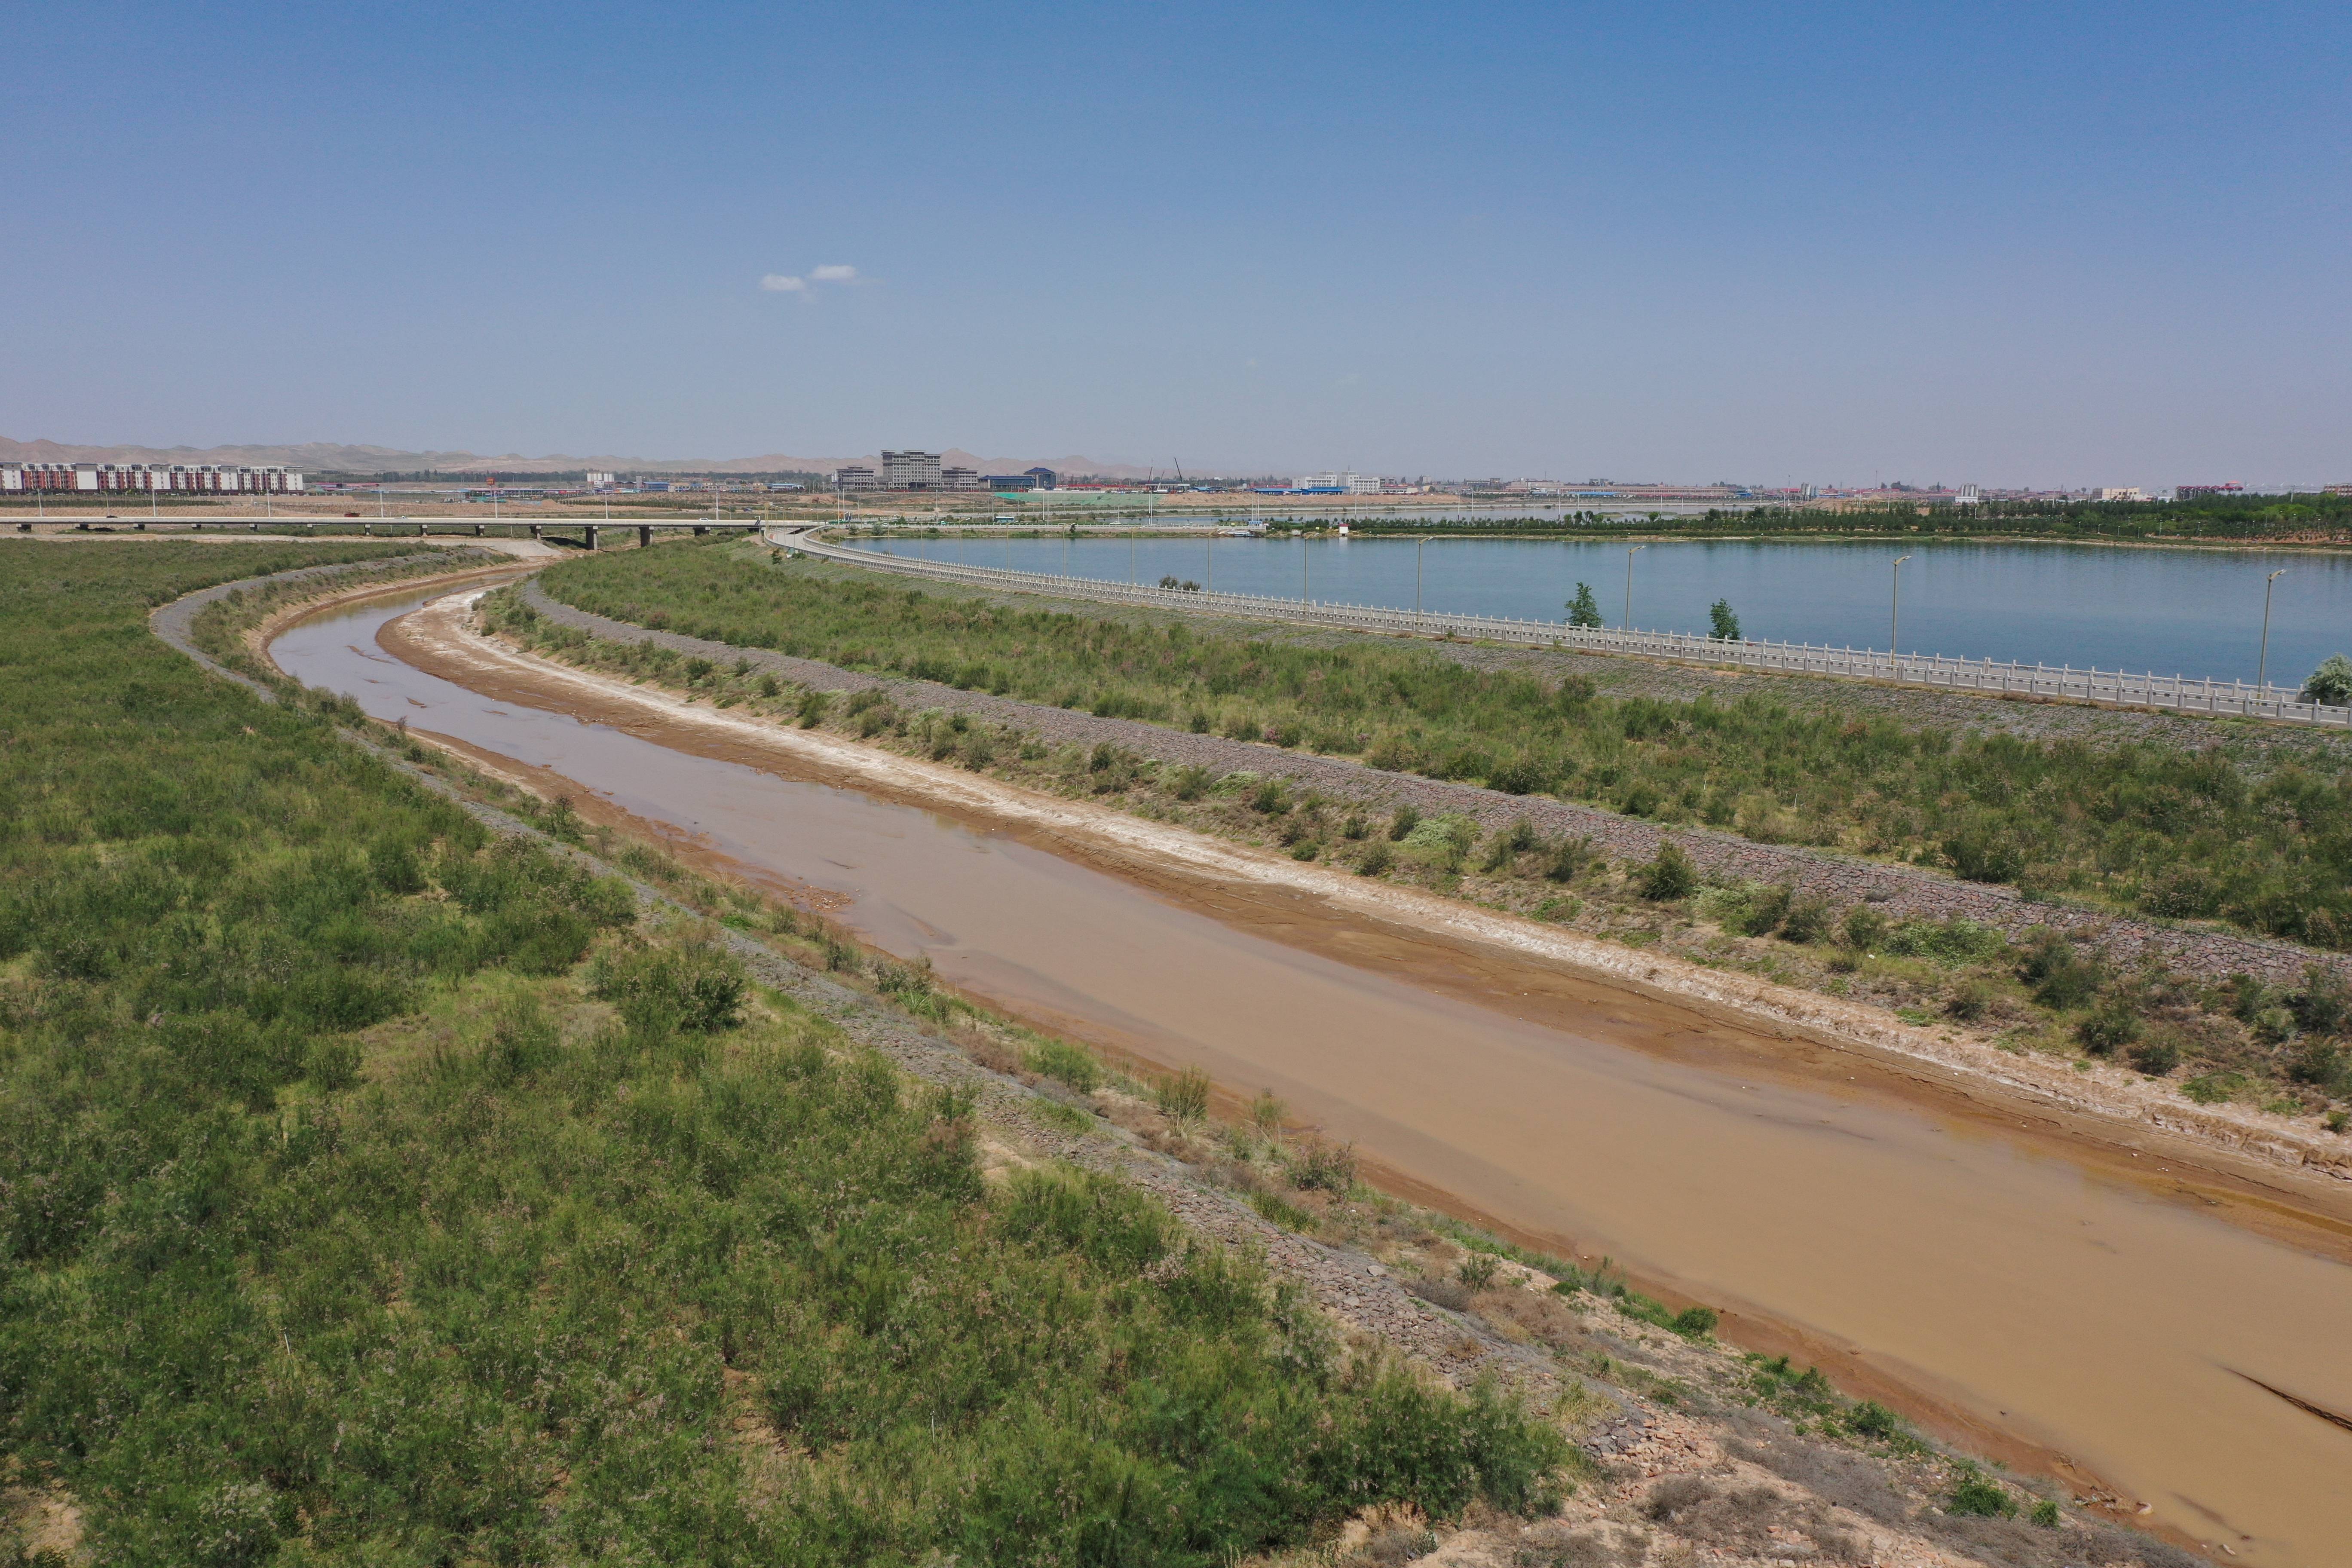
522;581;2352;983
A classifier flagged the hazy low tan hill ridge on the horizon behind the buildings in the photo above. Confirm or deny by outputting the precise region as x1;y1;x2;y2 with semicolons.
0;435;1194;480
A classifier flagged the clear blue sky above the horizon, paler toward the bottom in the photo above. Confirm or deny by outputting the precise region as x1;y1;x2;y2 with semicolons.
0;2;2352;484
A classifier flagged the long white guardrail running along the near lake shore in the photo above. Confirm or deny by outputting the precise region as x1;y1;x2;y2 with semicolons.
772;534;2352;729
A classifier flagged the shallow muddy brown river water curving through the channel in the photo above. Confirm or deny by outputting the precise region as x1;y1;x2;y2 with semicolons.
273;588;2352;1568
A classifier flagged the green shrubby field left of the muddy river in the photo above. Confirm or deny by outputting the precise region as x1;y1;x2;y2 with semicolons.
14;545;1566;1563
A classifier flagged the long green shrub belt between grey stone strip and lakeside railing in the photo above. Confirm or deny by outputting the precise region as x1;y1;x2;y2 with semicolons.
543;548;2352;950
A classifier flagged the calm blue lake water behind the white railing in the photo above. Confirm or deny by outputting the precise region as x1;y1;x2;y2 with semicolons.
858;536;2352;684
